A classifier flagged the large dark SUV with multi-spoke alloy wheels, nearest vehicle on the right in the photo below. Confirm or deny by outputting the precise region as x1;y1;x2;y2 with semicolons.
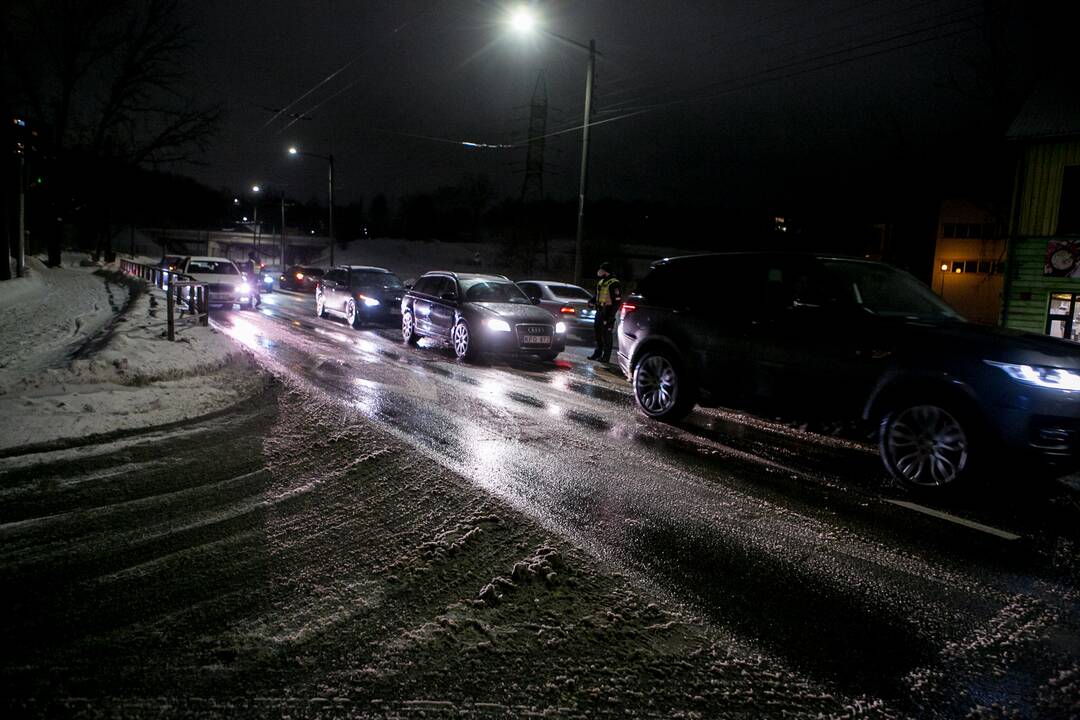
618;253;1080;488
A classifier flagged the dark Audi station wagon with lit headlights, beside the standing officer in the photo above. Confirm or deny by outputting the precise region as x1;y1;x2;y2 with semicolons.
402;271;566;359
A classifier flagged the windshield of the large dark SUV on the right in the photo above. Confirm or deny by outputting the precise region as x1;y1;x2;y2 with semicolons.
824;260;963;320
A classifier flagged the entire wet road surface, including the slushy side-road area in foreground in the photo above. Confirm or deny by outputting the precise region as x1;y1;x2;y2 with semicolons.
0;294;1080;718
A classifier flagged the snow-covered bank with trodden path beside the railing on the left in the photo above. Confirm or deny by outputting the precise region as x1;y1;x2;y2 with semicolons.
0;258;260;456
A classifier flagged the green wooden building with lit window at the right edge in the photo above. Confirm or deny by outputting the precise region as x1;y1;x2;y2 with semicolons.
1001;77;1080;341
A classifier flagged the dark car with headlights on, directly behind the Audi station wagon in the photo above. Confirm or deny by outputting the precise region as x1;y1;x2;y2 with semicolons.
315;266;405;327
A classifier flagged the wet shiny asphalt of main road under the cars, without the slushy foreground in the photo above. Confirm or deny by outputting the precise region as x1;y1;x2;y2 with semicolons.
216;294;1080;702
